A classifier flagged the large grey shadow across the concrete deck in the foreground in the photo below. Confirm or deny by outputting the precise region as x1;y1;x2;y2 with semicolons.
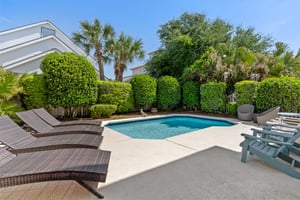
101;147;300;200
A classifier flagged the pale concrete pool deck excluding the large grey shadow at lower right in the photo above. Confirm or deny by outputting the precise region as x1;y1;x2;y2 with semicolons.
0;115;298;200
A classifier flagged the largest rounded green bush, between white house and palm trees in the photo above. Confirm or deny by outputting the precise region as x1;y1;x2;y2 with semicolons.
41;53;97;108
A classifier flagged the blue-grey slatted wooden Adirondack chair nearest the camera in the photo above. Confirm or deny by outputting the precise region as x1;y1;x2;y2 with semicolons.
240;131;300;179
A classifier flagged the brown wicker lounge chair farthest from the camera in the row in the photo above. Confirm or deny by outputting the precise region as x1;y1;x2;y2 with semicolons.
33;108;101;127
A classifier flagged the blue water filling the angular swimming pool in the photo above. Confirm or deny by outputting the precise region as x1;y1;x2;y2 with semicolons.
106;116;233;139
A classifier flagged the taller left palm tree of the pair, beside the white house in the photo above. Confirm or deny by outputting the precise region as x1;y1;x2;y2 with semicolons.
72;19;115;80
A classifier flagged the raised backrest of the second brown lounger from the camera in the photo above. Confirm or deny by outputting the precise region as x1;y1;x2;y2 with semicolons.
0;116;36;149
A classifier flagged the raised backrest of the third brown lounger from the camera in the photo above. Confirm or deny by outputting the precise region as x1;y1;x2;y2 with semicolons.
16;110;53;133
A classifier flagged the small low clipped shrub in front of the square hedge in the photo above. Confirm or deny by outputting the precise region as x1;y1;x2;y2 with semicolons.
90;104;117;119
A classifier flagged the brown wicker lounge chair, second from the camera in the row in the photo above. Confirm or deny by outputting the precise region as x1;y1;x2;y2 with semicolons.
0;116;103;154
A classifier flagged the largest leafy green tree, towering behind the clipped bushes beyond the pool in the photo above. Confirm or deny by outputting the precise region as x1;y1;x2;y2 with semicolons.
146;13;273;80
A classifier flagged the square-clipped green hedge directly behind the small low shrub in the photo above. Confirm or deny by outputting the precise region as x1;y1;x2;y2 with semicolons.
97;80;134;113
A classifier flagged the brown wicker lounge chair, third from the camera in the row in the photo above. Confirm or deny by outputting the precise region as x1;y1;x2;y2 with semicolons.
16;110;103;137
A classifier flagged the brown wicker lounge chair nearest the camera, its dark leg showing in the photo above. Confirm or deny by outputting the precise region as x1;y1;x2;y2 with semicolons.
0;148;110;198
